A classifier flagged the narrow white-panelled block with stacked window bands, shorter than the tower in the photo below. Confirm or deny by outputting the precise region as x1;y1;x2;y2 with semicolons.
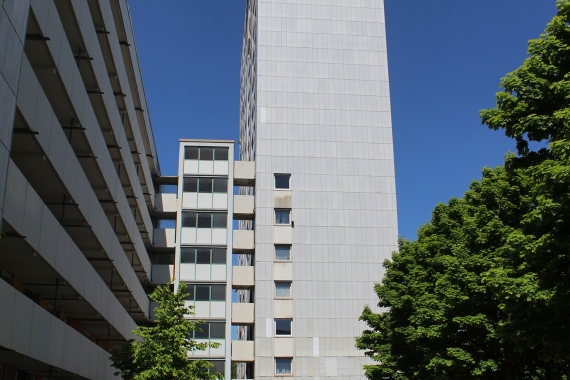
174;140;234;378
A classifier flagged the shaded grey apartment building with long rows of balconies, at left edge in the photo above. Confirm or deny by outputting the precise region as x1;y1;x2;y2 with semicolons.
0;0;164;380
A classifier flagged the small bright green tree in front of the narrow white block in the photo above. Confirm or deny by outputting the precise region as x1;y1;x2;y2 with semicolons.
111;283;223;380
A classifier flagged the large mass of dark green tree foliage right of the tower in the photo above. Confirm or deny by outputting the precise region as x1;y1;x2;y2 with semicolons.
357;0;570;380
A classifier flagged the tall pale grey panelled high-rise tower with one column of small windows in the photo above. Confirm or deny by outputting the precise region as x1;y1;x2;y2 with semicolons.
234;0;398;379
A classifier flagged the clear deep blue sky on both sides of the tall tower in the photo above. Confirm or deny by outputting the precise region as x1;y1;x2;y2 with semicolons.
130;0;556;239
